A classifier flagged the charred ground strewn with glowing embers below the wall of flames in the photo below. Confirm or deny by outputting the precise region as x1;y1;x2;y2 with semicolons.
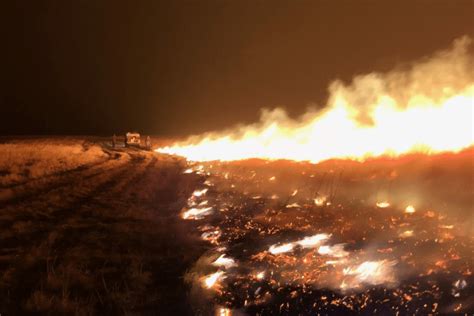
182;150;474;315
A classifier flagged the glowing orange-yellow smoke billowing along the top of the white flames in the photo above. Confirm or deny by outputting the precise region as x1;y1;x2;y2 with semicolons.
186;36;474;144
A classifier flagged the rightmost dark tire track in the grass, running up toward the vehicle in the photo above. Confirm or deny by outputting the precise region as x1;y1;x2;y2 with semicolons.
0;155;156;311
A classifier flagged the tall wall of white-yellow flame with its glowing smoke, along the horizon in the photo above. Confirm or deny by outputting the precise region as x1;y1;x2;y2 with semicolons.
157;37;474;163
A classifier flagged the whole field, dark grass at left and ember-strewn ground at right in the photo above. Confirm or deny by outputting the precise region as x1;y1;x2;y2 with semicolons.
0;138;474;315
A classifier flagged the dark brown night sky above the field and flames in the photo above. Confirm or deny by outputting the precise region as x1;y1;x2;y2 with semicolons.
0;0;474;136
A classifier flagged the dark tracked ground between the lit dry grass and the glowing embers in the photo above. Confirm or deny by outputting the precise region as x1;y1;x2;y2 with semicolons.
0;144;204;315
